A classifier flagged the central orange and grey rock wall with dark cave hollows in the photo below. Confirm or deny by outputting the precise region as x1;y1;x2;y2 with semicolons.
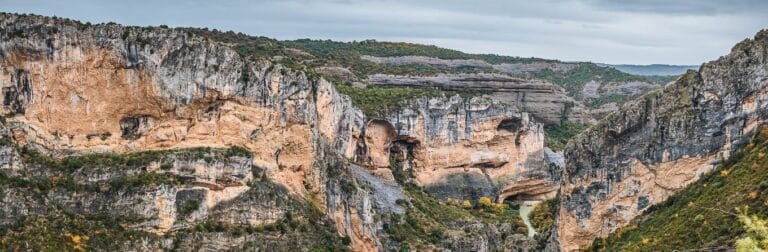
360;96;557;201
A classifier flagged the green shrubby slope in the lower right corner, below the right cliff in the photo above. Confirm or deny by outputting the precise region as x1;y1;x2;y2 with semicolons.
592;127;768;251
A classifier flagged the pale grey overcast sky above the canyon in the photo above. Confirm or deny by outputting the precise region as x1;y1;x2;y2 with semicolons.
0;0;768;65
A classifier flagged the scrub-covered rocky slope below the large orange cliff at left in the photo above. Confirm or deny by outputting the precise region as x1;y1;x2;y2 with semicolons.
0;139;349;251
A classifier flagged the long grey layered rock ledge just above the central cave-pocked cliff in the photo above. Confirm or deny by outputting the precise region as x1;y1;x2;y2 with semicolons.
368;74;592;125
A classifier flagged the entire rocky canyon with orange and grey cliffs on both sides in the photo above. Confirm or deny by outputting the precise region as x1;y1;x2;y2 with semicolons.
0;13;768;251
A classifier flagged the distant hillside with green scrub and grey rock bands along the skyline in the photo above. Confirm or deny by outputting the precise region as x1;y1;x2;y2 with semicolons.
186;28;674;124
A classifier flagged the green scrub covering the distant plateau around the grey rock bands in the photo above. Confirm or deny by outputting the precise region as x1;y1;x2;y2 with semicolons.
177;25;674;116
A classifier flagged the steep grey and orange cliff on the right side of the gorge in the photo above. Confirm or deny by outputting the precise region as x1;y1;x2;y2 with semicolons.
558;31;768;251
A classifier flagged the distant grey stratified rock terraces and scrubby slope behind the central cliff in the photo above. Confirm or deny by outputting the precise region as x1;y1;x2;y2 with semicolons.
358;55;660;125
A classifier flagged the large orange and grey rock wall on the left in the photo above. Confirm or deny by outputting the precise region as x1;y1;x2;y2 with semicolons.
0;14;376;250
